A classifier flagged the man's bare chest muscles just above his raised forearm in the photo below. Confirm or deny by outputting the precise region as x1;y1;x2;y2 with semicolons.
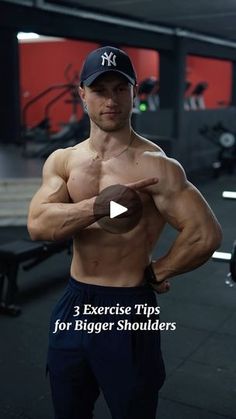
67;154;145;202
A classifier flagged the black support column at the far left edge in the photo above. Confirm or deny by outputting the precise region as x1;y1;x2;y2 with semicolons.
0;28;20;142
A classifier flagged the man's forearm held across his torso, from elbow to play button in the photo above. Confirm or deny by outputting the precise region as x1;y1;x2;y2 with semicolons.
28;197;102;240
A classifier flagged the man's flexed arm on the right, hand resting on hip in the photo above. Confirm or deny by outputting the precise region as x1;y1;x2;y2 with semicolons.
148;158;222;288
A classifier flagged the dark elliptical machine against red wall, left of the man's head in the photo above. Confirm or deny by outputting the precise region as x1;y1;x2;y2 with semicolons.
21;65;89;157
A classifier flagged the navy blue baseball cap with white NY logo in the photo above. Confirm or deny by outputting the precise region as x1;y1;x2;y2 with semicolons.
80;46;137;86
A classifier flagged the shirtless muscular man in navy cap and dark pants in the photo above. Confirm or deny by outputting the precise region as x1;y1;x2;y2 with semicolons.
28;47;221;419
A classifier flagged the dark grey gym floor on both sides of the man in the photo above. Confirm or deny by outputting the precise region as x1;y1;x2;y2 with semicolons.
0;148;236;419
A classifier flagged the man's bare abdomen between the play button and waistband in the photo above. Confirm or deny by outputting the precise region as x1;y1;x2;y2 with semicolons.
71;208;164;287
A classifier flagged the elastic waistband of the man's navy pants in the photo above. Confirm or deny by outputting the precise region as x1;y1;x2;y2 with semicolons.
68;277;152;295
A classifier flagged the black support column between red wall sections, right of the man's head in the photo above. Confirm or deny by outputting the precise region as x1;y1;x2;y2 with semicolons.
160;37;187;149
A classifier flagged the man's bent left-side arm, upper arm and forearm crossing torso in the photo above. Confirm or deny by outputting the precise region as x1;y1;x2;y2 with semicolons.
27;150;105;240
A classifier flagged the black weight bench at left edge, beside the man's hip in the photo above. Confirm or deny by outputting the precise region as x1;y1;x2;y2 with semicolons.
0;239;71;316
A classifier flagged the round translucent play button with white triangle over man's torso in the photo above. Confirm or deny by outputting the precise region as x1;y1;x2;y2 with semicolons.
93;185;143;234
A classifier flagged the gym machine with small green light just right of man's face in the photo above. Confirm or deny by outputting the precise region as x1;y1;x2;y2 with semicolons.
134;77;159;112
